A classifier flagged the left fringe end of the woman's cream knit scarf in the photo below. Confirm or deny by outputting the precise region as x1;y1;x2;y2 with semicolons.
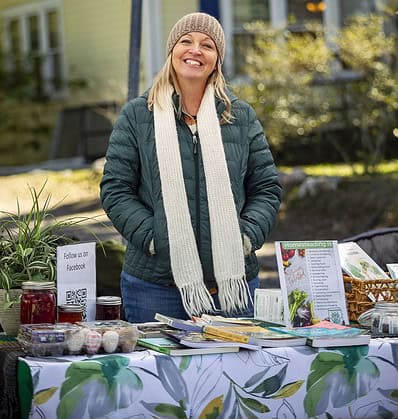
180;283;216;317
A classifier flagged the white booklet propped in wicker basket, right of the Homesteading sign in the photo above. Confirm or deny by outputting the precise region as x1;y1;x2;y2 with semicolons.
338;242;389;279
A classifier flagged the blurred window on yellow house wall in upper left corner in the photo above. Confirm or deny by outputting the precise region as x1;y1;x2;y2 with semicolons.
3;0;65;97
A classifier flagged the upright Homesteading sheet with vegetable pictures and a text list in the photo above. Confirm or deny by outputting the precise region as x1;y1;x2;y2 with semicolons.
275;240;349;327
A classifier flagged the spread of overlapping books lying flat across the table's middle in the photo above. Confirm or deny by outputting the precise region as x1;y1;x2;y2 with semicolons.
138;313;370;355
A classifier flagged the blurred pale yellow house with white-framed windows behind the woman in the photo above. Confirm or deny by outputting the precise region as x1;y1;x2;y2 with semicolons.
0;0;392;163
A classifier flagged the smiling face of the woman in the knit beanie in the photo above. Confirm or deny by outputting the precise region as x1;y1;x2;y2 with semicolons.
172;32;218;84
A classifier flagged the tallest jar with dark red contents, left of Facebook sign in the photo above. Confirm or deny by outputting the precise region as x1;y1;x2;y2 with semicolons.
21;281;57;324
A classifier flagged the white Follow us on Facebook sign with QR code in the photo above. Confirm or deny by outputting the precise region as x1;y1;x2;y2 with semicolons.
57;242;97;321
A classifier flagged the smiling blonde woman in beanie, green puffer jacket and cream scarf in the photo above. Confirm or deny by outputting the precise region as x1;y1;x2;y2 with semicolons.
101;13;281;322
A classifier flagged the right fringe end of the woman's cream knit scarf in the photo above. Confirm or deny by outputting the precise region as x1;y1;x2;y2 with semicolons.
217;276;253;314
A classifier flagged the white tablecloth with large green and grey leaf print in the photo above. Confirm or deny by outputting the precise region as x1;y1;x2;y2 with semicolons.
18;339;398;419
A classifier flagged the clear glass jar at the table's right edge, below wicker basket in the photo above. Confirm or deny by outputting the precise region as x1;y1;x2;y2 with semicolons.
370;301;398;337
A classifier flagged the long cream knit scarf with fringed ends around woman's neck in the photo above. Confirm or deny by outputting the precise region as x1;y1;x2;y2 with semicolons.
154;85;249;316
